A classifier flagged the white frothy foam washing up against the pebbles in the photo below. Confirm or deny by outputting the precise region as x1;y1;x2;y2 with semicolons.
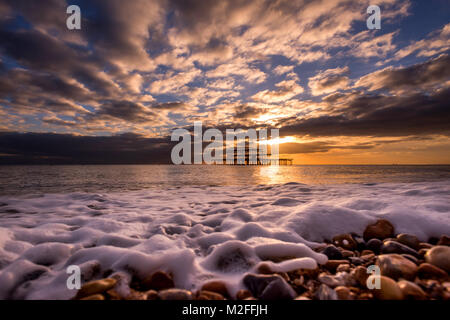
0;181;450;299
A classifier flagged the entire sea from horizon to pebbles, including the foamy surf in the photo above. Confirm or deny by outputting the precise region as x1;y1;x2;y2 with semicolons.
0;166;450;299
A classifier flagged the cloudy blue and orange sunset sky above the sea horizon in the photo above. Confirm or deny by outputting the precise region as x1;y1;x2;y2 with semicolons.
0;0;450;164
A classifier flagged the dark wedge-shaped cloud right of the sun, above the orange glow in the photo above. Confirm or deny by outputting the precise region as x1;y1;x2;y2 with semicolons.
280;88;450;136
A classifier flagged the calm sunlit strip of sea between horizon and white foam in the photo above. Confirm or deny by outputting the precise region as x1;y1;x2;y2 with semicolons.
0;165;450;195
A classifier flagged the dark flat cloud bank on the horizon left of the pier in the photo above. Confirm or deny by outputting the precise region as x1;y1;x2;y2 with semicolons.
0;132;172;164
